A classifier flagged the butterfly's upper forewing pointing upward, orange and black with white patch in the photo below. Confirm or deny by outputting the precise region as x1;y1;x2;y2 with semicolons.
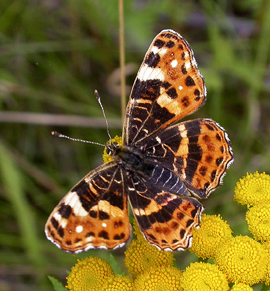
123;30;206;146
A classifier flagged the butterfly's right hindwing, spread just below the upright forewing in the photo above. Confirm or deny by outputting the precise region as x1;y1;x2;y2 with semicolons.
142;119;233;199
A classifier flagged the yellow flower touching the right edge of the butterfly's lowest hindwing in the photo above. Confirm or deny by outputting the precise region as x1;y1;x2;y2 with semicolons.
189;214;232;259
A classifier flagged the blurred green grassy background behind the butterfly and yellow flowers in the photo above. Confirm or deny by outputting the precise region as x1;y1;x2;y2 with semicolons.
0;0;270;291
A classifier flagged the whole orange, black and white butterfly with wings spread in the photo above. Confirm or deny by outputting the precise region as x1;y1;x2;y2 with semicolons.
45;29;233;253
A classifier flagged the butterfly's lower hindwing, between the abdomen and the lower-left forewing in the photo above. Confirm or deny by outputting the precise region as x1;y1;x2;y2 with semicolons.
128;178;203;251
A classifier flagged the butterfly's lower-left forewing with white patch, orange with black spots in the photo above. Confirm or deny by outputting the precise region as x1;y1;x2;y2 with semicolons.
45;162;130;253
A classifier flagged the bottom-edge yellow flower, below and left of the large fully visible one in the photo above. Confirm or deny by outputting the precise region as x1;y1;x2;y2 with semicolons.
180;262;229;291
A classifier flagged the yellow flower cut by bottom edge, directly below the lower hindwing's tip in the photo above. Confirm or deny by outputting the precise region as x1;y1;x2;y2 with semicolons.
134;267;182;291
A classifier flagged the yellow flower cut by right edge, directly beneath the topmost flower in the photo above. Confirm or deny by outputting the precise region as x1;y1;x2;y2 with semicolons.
246;204;270;241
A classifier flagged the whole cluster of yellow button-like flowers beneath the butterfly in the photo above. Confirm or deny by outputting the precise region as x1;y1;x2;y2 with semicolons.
52;172;270;291
